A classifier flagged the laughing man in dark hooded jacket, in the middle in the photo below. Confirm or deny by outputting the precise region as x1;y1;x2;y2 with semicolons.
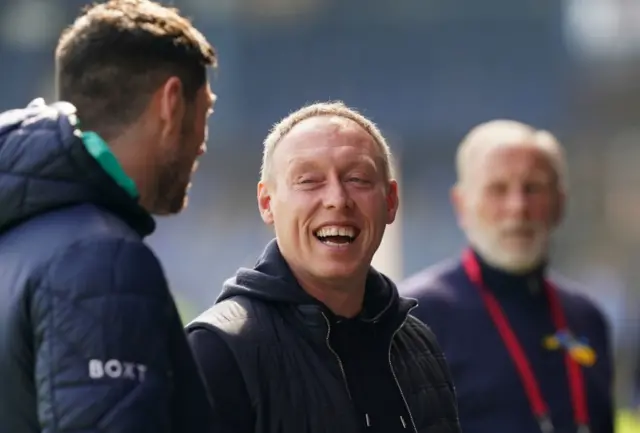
188;103;459;433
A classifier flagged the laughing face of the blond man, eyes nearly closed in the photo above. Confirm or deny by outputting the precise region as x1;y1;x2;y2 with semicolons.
258;116;398;281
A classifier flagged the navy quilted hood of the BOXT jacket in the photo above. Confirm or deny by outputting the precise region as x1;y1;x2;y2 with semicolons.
0;99;155;236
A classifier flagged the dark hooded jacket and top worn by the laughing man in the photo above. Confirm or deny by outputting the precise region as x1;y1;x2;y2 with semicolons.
188;241;459;433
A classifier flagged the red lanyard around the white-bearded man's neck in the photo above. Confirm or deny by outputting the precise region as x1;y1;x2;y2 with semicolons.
462;250;589;433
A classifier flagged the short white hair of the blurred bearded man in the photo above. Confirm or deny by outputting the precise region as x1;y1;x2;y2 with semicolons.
456;119;566;189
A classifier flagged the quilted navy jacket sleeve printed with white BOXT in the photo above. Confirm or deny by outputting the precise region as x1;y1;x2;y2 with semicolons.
31;239;173;433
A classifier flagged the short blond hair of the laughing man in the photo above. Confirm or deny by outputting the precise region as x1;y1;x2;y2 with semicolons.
260;101;393;182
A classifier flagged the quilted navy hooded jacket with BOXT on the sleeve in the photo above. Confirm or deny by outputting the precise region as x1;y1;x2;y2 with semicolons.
0;99;211;433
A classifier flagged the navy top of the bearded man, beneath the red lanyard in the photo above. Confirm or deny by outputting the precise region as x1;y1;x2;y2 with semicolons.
399;251;613;433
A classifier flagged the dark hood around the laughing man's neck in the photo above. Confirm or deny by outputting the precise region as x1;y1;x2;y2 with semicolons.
216;239;415;320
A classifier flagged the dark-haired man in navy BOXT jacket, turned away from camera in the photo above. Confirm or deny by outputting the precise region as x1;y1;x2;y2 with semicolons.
0;0;216;433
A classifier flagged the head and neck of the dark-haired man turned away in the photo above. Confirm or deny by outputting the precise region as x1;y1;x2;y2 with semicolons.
56;0;216;214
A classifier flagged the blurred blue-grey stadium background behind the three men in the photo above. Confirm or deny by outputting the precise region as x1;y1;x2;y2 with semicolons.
0;0;640;431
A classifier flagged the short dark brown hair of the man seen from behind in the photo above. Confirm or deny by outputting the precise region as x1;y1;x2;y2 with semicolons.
56;0;217;139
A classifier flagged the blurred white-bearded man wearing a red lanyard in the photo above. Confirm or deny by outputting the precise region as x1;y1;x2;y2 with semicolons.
400;120;613;433
